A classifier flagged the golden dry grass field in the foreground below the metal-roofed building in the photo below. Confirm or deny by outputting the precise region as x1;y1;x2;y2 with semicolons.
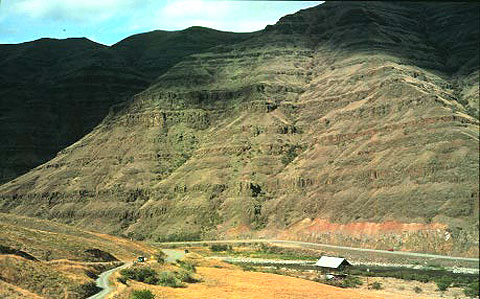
110;260;384;299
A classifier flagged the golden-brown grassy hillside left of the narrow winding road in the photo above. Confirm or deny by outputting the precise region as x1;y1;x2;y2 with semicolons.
0;213;155;298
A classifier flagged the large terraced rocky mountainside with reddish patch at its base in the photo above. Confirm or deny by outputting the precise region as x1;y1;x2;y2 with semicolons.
0;2;480;255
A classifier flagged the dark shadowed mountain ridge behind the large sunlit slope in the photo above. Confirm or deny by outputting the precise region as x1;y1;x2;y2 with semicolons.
0;27;250;183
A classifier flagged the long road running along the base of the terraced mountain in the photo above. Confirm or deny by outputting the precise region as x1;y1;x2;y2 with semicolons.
156;239;479;263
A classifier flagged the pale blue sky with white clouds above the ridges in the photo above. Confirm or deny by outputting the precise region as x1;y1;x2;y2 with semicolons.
0;0;322;45
